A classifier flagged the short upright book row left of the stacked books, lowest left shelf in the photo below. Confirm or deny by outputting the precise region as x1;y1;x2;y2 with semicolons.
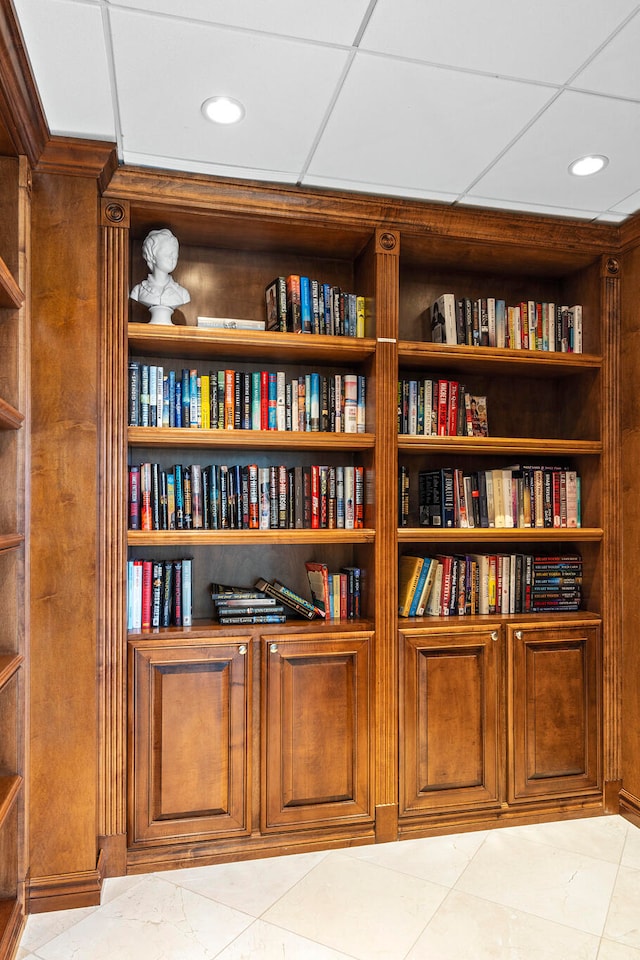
127;557;193;630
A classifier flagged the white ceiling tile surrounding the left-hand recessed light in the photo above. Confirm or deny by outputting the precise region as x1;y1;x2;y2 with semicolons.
111;9;348;172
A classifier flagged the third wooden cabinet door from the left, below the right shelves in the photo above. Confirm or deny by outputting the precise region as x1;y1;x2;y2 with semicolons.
400;624;501;815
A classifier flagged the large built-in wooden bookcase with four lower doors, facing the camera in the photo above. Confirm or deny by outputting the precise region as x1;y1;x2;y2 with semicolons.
97;171;619;870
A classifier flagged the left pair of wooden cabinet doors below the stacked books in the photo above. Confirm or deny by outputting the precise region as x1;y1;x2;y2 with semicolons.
129;631;373;845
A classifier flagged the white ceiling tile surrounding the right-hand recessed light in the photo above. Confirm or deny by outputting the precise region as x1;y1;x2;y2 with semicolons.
470;91;640;211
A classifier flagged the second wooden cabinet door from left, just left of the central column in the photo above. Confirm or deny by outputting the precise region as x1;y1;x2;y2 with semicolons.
261;632;373;831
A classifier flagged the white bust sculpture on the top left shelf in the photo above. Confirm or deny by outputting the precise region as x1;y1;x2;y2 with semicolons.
130;227;191;324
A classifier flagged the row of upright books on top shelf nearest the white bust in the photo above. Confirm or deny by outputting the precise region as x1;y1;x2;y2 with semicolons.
265;274;365;337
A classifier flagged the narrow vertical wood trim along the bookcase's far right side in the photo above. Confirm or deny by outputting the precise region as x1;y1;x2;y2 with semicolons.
600;255;622;781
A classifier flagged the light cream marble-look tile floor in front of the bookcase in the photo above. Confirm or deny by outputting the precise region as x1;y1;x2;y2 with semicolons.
18;816;640;960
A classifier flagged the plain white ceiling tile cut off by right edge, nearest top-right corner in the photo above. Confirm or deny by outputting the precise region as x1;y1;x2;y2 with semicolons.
572;14;640;100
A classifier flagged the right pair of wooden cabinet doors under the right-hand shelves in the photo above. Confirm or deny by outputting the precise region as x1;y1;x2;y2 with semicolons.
399;618;602;819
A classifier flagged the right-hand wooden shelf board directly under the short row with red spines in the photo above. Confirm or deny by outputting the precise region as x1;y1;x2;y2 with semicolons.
398;434;602;457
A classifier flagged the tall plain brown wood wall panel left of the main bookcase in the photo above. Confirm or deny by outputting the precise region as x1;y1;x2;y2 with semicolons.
30;169;99;910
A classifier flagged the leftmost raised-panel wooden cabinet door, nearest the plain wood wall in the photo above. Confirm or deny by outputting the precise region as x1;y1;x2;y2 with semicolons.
129;638;251;842
